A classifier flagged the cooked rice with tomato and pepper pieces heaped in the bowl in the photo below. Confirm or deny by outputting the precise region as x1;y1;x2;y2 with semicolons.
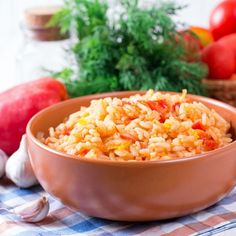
38;90;232;161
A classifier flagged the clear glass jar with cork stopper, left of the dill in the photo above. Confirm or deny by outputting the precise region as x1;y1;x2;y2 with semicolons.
16;7;72;83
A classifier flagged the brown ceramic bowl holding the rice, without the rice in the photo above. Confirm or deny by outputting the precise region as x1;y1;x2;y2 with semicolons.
27;92;236;221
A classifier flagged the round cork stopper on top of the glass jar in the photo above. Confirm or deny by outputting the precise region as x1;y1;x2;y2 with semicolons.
24;5;68;41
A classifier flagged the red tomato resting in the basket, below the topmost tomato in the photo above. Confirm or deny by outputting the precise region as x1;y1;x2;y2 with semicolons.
202;43;236;80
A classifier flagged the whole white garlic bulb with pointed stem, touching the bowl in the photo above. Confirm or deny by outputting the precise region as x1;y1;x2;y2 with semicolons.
6;135;38;188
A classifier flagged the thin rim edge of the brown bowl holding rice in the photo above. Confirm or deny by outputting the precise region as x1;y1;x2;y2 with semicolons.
26;90;236;166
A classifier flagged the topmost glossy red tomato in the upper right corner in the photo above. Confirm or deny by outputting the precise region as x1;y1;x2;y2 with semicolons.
210;0;236;40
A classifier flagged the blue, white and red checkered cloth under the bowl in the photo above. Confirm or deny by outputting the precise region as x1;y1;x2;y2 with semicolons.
0;179;236;236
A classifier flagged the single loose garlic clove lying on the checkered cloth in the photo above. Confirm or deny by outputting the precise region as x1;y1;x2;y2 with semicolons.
12;197;49;223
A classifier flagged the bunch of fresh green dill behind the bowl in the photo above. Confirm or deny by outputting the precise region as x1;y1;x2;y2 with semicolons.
51;0;206;96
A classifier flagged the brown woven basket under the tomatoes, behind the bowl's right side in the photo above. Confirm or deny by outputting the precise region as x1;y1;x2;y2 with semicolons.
203;78;236;107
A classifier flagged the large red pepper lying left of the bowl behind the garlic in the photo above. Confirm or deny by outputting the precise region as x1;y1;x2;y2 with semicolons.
0;78;67;155
